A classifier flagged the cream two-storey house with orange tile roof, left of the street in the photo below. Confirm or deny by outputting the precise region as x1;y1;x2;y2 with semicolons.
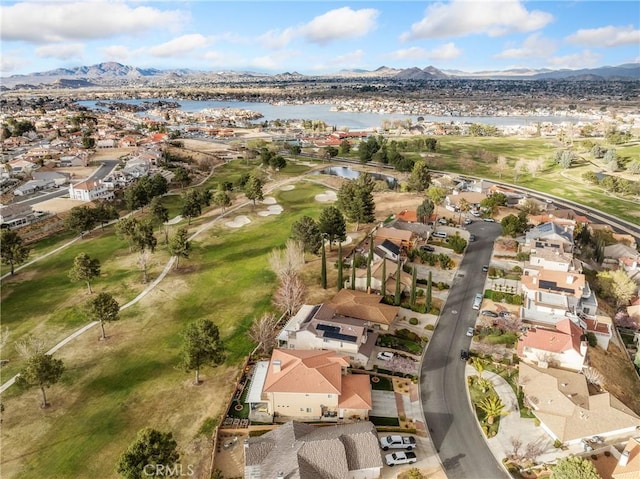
262;349;373;421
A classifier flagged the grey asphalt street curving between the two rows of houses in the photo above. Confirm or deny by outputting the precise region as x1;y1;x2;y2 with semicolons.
420;221;509;479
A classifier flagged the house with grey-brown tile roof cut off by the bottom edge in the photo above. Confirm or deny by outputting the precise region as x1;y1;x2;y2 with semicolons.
244;421;382;479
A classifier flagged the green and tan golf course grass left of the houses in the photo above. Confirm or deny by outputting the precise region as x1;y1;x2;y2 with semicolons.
1;183;330;478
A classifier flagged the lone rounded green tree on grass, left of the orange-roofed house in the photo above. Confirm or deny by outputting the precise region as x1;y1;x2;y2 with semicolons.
182;319;225;384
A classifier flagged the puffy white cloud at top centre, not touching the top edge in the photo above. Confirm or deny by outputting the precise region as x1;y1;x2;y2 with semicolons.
298;7;379;44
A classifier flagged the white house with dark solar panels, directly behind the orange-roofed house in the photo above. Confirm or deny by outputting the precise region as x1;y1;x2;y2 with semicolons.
278;304;378;367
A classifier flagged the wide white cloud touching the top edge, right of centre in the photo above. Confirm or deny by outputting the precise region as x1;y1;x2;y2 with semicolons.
400;0;553;41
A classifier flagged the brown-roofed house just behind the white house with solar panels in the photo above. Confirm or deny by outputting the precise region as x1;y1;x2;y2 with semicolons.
329;289;400;330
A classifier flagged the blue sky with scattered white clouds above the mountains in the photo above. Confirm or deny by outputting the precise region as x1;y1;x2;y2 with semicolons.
0;0;640;76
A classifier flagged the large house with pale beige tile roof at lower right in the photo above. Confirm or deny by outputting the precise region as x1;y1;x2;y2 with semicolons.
518;362;640;445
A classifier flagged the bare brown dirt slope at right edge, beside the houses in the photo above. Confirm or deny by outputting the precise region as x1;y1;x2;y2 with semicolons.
588;342;640;414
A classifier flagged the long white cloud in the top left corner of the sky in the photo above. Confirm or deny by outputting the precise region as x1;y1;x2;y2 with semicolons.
0;0;189;43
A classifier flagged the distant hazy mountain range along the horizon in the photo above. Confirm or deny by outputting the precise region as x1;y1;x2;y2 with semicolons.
0;62;640;90
